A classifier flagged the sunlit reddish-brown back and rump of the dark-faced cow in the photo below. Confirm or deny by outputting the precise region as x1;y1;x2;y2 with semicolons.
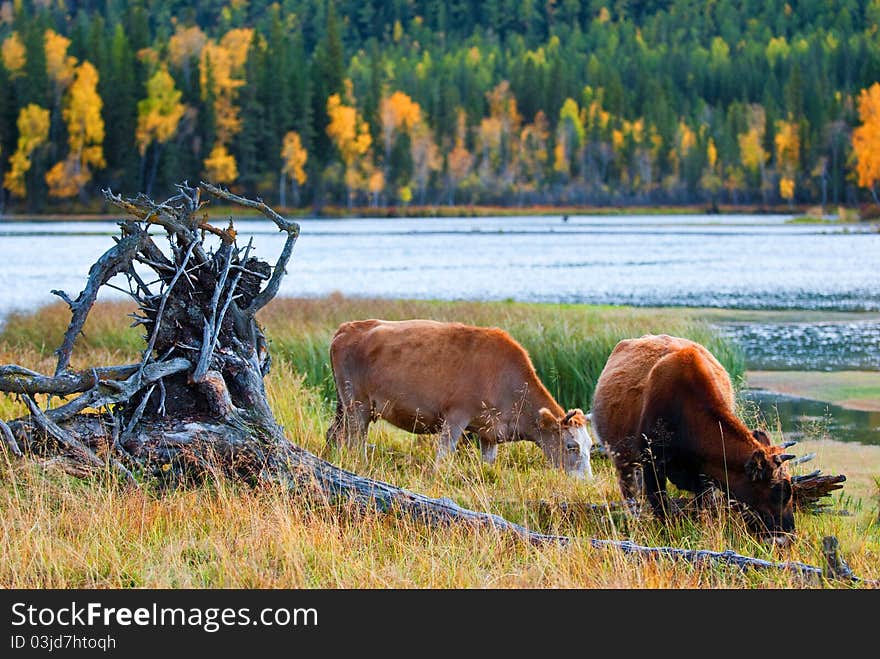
591;334;734;449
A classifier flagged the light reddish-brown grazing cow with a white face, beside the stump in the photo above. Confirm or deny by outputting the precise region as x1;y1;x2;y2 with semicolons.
327;320;593;477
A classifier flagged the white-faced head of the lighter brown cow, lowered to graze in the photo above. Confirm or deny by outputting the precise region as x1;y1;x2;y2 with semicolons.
538;407;593;478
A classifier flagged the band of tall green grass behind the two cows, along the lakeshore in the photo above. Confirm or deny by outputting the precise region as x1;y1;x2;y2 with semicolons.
261;296;745;409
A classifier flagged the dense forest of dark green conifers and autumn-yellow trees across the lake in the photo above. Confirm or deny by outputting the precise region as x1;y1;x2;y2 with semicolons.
0;0;880;211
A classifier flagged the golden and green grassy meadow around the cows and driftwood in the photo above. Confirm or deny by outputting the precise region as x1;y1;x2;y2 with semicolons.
0;296;880;589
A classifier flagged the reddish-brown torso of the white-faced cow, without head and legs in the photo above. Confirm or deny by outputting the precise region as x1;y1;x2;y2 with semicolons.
330;319;531;422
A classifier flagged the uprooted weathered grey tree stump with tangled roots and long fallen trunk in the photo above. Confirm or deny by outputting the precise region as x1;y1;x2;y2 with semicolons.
0;182;864;578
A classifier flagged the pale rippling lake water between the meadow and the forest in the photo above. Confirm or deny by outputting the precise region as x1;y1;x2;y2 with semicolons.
0;215;880;441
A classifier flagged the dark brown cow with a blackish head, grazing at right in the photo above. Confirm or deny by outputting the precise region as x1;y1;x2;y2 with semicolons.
591;335;794;543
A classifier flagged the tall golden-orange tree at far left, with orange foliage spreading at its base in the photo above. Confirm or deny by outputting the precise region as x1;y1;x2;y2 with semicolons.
46;61;104;198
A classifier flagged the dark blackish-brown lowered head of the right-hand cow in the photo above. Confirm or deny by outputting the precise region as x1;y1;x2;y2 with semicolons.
733;442;794;544
